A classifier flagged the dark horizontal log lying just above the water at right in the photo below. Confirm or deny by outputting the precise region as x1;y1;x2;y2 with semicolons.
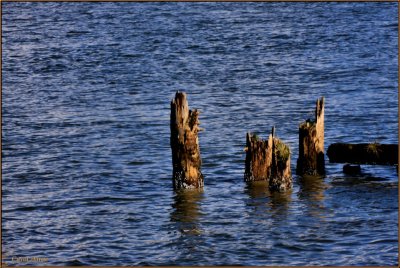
327;143;399;165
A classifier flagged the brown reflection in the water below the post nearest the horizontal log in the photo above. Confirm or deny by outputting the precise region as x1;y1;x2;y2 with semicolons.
298;176;328;218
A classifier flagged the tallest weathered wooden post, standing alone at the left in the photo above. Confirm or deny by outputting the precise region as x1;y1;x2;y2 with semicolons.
171;92;203;189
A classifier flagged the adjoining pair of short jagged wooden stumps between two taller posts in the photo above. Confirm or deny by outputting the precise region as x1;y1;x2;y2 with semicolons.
244;128;292;191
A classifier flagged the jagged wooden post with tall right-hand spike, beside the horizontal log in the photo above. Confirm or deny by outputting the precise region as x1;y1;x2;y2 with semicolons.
296;97;325;176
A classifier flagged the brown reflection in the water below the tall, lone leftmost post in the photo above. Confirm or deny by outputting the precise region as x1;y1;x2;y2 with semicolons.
171;189;204;235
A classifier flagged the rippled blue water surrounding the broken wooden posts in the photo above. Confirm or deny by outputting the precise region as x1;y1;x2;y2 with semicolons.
2;2;398;266
